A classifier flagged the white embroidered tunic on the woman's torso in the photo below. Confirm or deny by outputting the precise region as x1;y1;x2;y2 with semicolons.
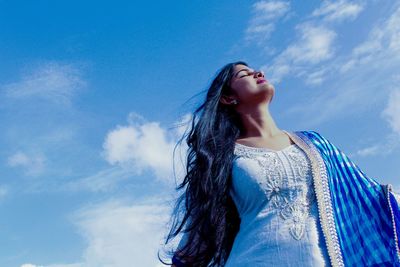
225;143;330;267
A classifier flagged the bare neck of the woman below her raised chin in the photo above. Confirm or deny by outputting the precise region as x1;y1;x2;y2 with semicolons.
239;105;281;138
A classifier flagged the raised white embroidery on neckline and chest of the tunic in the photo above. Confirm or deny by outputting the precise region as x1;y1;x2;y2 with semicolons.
235;143;316;240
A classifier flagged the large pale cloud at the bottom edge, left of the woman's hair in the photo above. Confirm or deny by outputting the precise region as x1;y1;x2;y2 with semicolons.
73;199;170;267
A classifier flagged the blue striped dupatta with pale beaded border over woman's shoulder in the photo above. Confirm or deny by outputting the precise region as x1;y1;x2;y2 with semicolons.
286;131;400;267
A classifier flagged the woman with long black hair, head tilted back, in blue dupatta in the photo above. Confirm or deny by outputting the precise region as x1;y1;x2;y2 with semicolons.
158;61;400;267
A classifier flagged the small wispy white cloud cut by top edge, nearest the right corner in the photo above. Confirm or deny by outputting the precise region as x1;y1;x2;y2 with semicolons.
312;0;364;21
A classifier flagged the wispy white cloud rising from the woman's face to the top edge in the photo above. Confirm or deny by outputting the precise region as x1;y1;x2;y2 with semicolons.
261;0;364;86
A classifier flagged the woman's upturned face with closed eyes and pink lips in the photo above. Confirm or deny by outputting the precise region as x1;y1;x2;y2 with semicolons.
230;64;275;105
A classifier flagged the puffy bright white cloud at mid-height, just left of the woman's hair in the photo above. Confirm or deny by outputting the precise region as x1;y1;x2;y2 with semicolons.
67;112;192;192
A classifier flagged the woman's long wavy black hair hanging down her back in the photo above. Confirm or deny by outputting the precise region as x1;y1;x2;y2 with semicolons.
158;61;248;266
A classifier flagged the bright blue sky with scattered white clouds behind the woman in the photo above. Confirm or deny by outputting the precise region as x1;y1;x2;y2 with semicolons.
0;0;400;267
